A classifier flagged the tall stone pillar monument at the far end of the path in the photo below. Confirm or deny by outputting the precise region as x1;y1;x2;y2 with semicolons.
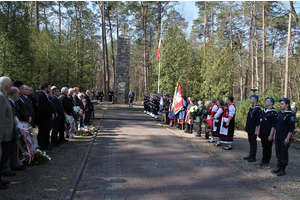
114;23;130;103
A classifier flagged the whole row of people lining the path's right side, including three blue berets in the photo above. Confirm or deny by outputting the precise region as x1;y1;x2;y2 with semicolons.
144;93;298;176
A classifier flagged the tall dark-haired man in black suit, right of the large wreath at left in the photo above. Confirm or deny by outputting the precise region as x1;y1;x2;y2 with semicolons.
37;83;54;150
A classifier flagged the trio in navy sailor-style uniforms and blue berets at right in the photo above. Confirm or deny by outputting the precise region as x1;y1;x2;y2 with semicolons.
244;94;297;176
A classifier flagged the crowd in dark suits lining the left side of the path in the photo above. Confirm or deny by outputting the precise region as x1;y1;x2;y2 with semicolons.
0;76;93;189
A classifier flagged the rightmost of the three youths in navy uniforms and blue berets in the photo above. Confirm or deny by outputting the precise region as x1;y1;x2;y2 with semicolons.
271;98;295;176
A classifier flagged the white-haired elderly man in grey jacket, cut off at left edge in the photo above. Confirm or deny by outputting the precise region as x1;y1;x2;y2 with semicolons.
0;76;14;190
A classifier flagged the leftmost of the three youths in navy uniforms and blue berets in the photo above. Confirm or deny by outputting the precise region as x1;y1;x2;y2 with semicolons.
244;94;261;162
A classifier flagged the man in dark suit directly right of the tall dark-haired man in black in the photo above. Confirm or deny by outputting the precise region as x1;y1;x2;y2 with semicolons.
51;88;67;147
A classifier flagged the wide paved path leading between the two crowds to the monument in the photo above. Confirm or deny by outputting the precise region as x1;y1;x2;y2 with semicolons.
73;110;280;200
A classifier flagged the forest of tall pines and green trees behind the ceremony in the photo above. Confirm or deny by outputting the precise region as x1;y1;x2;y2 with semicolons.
0;1;300;128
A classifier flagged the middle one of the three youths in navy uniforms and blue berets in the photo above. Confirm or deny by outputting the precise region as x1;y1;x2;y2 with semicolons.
258;97;278;168
